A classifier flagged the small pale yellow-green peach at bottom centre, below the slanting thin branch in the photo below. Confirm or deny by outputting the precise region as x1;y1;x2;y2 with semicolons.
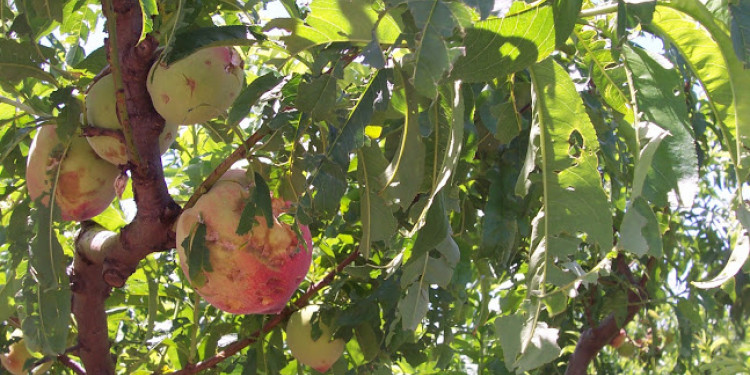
286;305;344;372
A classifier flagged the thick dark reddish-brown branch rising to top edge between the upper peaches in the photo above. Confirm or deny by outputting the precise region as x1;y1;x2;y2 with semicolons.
102;0;181;287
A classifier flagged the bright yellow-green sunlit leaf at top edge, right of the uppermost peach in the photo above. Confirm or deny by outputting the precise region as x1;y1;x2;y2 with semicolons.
264;0;401;55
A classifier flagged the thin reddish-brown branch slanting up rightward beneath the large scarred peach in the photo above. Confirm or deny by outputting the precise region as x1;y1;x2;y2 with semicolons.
172;250;359;375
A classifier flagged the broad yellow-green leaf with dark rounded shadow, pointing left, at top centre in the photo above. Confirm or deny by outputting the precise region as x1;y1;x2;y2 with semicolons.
452;2;556;82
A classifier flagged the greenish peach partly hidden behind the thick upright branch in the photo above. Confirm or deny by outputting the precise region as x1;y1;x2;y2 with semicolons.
86;74;179;165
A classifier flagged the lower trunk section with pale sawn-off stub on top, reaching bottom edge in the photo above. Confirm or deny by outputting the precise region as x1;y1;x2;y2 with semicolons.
70;222;115;375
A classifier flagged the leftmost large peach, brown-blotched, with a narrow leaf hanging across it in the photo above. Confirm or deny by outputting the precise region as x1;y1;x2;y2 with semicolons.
26;126;120;221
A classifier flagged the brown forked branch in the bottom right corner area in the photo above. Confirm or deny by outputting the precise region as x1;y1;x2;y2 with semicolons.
565;254;654;375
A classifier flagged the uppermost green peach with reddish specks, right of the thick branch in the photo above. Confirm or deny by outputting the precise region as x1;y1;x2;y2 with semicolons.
146;47;244;125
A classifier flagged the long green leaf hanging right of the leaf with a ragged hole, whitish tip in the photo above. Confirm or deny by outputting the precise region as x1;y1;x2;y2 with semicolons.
623;45;698;207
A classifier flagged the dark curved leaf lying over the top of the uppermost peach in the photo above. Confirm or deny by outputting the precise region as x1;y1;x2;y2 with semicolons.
163;25;266;65
